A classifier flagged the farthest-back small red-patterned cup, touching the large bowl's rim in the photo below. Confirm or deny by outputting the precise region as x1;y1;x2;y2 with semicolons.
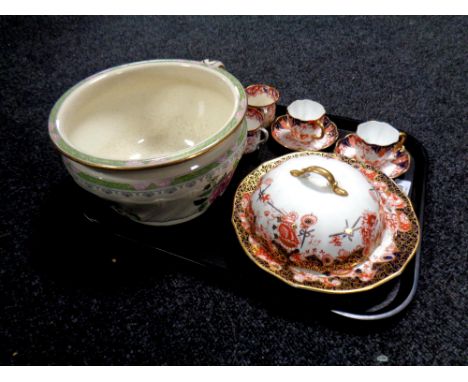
245;84;280;127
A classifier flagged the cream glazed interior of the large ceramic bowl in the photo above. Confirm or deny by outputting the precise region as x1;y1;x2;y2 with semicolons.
56;63;237;161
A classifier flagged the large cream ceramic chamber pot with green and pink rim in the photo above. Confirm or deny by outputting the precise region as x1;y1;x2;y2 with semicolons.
49;60;247;225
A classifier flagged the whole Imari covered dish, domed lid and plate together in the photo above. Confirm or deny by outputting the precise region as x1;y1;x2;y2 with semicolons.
232;152;420;294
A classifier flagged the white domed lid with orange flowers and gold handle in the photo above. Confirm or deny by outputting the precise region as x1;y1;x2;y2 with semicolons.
251;156;384;271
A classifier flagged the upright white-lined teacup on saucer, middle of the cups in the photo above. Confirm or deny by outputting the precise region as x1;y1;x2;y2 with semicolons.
287;99;325;144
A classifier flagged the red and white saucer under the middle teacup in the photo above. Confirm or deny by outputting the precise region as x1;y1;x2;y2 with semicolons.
271;115;338;151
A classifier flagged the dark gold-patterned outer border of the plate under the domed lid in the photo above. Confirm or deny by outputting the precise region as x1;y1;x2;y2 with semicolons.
231;151;421;294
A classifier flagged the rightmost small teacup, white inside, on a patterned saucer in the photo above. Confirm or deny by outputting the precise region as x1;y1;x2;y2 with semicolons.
356;121;406;155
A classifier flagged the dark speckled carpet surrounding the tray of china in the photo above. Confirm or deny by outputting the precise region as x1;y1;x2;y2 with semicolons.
0;17;468;365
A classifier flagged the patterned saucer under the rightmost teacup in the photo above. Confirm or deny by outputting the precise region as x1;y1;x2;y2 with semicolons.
334;134;411;178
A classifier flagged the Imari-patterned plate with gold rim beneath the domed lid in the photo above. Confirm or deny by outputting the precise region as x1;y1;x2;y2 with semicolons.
232;152;420;294
